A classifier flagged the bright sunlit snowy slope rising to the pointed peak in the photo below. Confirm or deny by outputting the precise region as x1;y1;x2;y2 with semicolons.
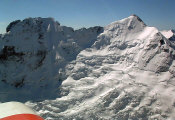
1;15;175;120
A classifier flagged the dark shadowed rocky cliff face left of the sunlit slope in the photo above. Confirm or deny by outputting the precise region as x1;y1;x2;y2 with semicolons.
0;18;103;100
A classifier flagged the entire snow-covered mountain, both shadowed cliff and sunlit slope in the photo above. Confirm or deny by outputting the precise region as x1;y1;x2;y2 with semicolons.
0;15;175;120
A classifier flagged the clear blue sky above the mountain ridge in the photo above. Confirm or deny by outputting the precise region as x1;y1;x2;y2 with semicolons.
0;0;175;33
